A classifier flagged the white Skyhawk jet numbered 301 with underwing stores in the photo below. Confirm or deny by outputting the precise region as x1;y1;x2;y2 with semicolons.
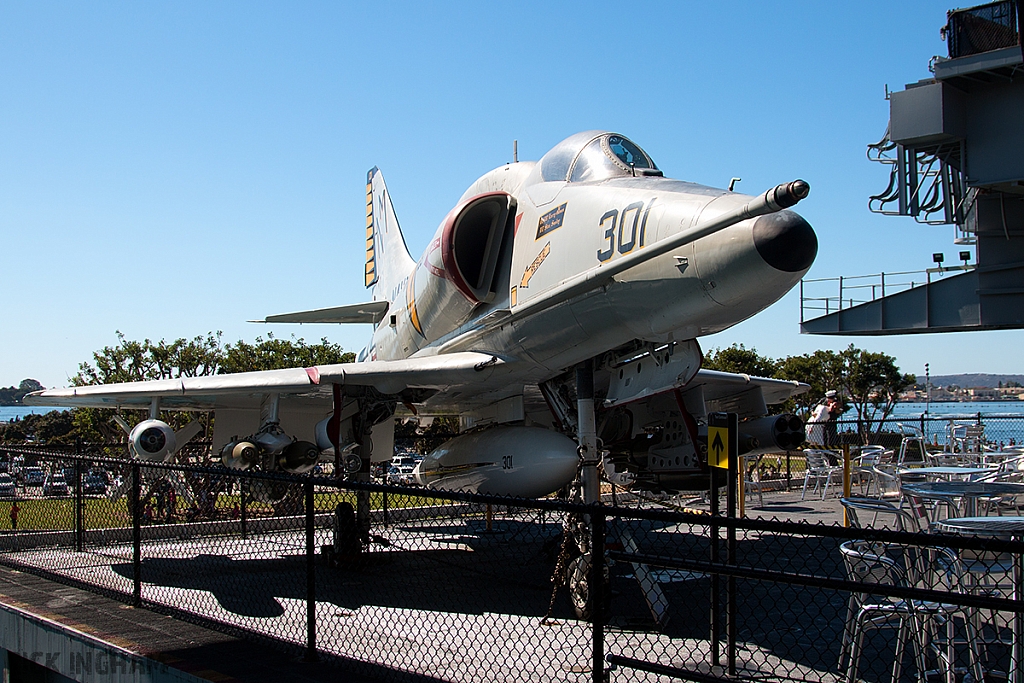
26;131;817;509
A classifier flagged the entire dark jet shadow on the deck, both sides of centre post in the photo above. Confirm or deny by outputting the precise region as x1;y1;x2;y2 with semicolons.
113;521;846;669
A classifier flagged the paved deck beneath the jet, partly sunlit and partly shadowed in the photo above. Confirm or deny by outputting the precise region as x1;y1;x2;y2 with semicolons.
0;489;843;683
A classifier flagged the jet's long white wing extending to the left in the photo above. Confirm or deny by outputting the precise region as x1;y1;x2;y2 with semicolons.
25;351;507;410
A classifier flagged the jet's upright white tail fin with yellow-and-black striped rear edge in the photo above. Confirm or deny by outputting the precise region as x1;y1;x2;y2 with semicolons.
366;166;416;300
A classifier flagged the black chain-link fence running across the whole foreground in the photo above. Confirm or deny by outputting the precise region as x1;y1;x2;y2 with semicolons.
0;447;1024;681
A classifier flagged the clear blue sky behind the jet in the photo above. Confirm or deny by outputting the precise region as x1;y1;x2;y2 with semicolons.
0;0;1022;386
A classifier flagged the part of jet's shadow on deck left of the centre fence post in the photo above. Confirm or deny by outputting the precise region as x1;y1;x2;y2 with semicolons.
113;524;572;617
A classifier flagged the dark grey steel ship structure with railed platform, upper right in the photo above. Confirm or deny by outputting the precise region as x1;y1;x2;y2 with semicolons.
801;0;1024;335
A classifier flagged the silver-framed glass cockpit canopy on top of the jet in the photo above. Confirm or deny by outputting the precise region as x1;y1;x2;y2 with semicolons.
541;131;662;182
